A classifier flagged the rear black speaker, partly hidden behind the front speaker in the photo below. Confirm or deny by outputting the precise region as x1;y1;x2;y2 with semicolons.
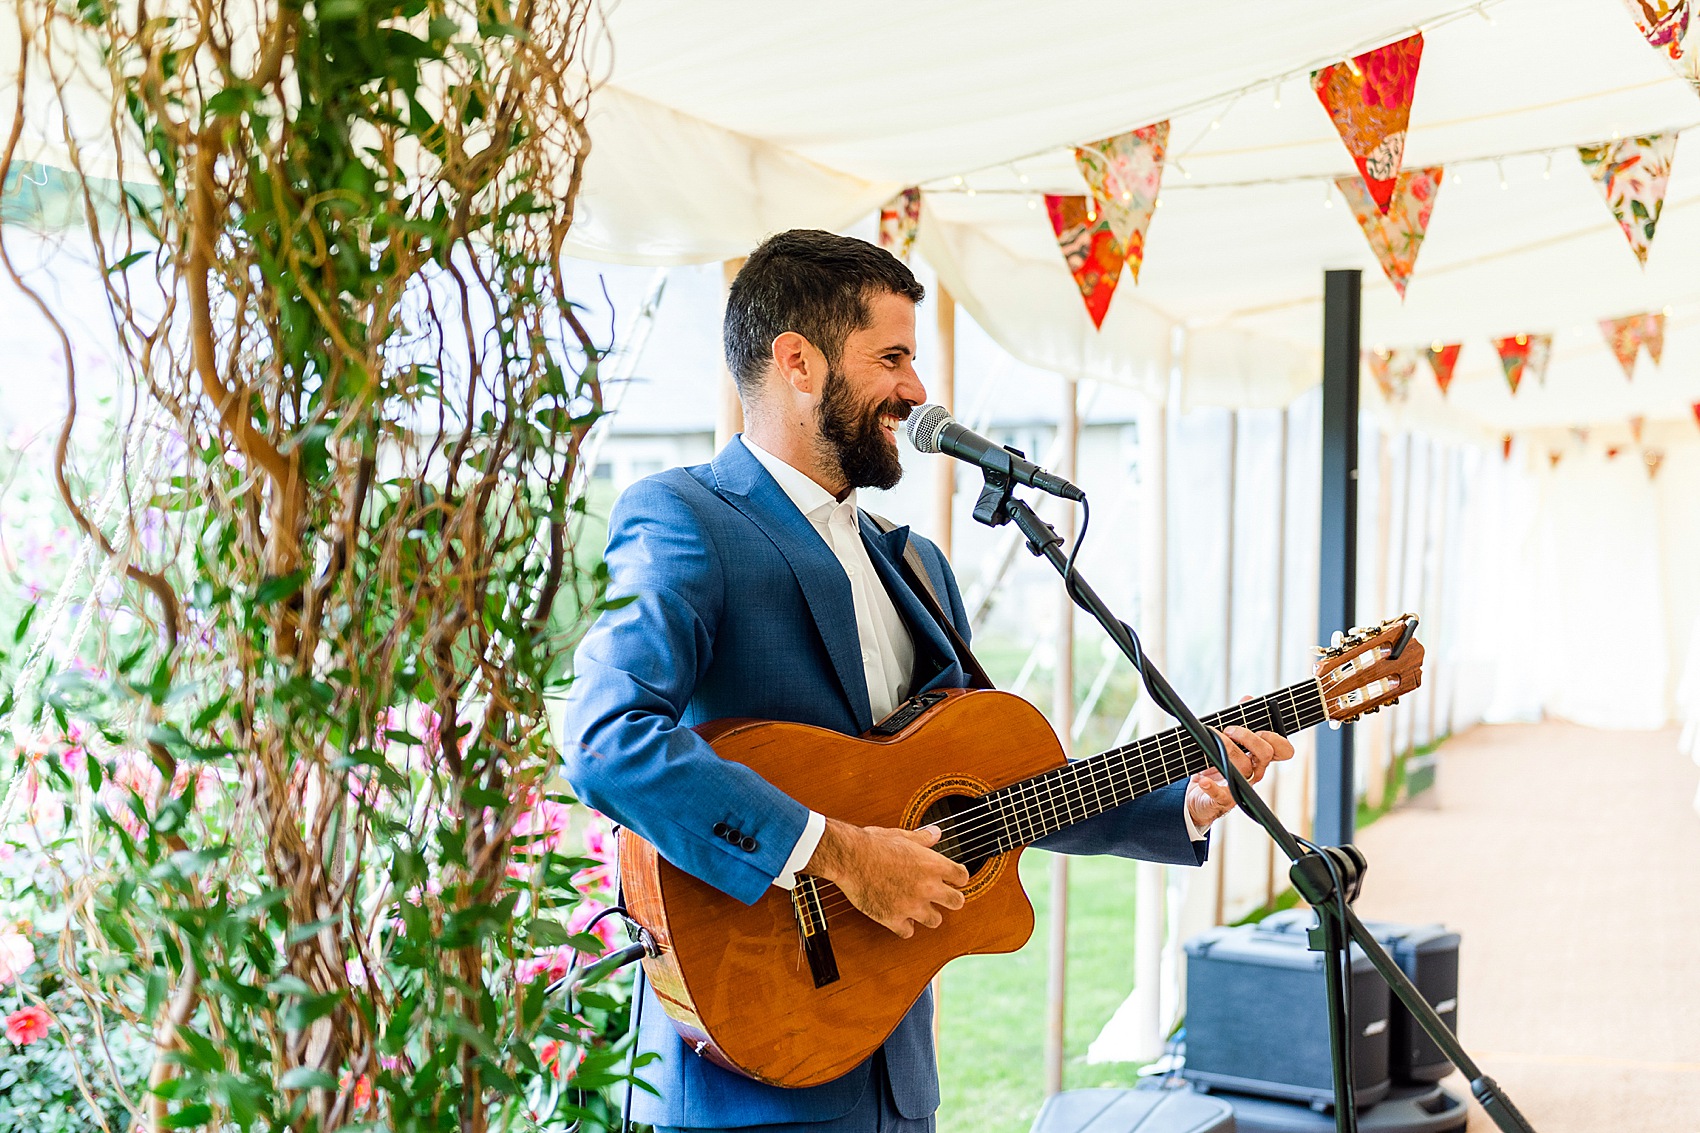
1258;908;1460;1085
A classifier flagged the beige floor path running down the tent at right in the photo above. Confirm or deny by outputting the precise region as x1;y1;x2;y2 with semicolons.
1358;723;1700;1133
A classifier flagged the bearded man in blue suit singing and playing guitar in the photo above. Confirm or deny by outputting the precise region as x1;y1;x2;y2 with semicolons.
566;231;1292;1133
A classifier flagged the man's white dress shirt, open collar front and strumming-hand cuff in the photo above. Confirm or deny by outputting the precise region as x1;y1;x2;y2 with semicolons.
743;437;915;890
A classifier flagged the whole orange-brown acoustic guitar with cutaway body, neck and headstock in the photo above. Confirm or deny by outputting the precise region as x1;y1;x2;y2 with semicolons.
621;614;1423;1087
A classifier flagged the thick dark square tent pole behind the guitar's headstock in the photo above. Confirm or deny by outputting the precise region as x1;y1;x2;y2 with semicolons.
1316;269;1363;845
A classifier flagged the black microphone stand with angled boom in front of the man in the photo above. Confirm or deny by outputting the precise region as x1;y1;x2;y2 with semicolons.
974;449;1535;1133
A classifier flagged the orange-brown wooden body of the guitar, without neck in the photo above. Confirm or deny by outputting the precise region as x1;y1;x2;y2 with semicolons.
621;689;1064;1087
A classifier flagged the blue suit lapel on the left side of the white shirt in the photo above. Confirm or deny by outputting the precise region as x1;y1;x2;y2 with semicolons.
712;437;874;732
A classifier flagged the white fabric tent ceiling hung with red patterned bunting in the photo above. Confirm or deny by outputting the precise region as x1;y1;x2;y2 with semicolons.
561;0;1700;432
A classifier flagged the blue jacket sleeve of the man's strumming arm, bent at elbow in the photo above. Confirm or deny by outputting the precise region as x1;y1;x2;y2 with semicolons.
563;478;808;903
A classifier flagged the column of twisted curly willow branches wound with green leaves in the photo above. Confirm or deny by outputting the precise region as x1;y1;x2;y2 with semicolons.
0;0;610;1133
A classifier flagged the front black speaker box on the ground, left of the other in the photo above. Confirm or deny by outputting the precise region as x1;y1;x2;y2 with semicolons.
1182;925;1392;1106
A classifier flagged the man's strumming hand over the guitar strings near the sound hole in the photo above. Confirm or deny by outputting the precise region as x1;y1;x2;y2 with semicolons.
804;818;967;939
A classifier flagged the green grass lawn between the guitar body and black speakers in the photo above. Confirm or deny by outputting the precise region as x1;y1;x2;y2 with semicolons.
938;849;1139;1133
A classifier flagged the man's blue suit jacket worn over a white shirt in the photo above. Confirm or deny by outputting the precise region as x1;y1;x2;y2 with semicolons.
564;439;1204;1126
